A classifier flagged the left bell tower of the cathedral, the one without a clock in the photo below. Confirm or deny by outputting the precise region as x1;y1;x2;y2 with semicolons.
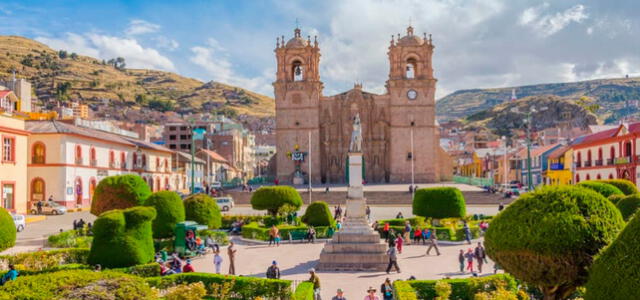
273;28;323;184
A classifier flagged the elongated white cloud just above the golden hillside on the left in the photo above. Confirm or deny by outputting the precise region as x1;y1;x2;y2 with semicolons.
36;33;175;71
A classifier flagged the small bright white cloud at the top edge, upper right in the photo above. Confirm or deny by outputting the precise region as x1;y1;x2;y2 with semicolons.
519;3;589;37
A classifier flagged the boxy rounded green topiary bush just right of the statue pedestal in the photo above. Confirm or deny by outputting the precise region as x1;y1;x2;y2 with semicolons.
413;187;467;219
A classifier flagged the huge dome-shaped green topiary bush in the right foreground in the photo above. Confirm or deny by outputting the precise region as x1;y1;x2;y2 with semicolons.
484;186;624;299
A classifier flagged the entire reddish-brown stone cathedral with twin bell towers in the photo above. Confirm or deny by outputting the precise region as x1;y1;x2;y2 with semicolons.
273;26;452;184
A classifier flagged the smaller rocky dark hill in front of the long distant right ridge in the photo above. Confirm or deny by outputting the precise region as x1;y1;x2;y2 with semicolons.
464;95;598;136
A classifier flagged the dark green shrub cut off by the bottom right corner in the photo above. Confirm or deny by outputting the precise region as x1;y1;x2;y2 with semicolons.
585;214;640;300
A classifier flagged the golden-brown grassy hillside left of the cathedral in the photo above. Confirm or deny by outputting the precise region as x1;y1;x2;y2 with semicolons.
0;36;275;117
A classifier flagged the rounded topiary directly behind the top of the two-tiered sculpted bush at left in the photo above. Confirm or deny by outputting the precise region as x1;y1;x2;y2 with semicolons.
91;174;151;216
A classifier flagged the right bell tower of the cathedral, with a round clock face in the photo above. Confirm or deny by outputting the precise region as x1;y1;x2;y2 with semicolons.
386;26;439;183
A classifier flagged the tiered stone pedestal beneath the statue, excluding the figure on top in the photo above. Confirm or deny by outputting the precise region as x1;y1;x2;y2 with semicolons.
316;153;389;271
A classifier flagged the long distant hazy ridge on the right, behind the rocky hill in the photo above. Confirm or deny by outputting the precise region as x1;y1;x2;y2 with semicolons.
436;77;640;123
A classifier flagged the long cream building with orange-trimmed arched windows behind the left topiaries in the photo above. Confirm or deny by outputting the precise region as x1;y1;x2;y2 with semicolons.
25;120;175;207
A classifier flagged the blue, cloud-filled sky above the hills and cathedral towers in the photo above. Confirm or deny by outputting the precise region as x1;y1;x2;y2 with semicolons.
0;0;640;98
